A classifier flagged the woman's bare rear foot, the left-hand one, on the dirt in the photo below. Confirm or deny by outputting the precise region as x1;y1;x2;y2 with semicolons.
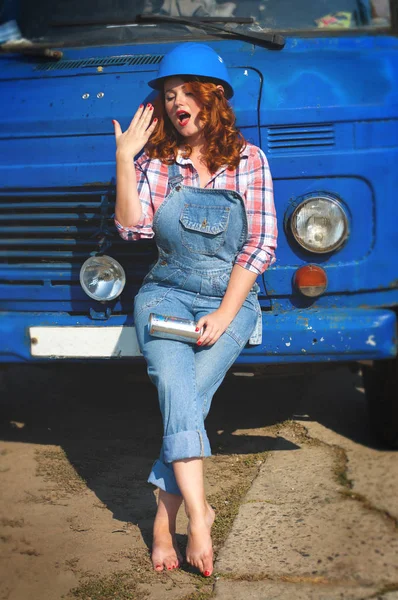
152;490;182;571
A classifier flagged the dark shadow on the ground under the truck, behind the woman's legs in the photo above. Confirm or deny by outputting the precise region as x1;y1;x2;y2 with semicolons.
0;364;374;545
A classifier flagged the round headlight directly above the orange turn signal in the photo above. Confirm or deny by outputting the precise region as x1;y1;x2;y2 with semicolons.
291;196;348;254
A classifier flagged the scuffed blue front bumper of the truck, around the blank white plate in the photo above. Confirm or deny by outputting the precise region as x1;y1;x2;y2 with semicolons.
0;309;396;364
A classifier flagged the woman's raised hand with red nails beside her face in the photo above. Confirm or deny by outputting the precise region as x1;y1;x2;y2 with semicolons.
113;104;158;160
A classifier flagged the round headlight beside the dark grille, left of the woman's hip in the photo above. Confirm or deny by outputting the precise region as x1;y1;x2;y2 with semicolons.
80;256;126;302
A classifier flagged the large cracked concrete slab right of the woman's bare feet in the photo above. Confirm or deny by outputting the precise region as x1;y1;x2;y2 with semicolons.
216;446;398;589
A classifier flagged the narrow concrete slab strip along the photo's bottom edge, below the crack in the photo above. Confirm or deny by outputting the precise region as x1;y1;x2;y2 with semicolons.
214;581;380;600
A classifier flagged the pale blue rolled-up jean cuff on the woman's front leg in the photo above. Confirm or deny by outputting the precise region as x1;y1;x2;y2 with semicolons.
163;429;211;463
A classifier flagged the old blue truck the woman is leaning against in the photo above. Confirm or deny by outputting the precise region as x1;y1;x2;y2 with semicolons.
0;0;398;446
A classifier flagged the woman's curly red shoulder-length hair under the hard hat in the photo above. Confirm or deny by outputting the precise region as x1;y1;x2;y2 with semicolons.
145;77;246;173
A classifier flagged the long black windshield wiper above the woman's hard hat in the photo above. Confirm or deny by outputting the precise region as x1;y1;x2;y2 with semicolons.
136;15;285;49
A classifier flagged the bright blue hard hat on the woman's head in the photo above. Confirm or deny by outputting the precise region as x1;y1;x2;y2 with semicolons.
148;42;234;98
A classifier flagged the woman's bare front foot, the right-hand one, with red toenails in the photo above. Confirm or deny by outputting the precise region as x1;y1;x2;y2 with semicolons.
187;504;215;577
